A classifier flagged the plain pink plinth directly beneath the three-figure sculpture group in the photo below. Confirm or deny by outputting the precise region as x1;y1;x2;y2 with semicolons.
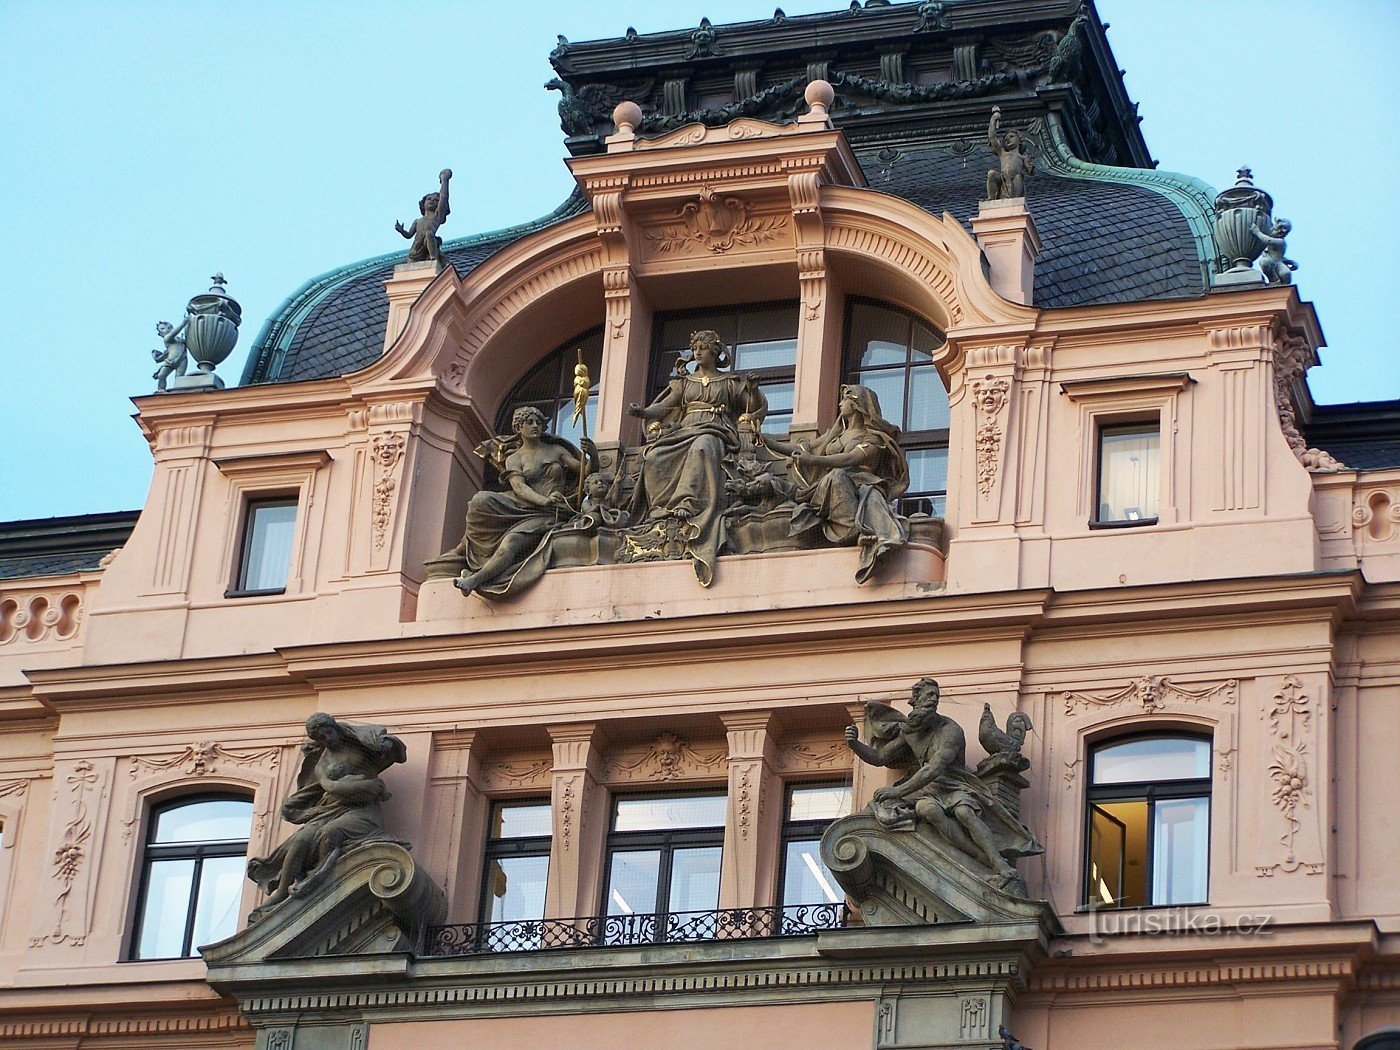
416;543;945;631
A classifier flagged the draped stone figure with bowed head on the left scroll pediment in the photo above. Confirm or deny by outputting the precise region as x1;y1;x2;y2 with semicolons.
248;711;407;924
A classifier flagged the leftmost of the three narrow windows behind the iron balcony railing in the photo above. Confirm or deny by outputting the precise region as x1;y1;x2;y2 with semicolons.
482;799;552;923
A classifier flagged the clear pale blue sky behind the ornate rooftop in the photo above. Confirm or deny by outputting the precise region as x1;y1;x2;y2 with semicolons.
0;0;1400;521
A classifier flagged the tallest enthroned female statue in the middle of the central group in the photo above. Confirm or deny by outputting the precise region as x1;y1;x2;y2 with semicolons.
627;330;769;587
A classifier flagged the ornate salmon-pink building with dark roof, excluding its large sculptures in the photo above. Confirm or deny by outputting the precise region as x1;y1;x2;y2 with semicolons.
0;0;1400;1050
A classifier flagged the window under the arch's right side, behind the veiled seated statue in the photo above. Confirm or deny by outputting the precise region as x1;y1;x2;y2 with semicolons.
841;298;949;518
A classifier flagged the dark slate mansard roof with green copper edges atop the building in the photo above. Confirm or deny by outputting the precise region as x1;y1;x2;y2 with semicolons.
244;0;1214;384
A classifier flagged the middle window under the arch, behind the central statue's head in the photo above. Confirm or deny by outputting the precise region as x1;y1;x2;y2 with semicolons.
647;302;797;434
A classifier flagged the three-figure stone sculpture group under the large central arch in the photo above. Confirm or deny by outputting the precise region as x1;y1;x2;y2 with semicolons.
428;330;938;598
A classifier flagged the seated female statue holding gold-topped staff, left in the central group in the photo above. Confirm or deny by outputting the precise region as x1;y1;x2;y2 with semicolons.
447;405;598;595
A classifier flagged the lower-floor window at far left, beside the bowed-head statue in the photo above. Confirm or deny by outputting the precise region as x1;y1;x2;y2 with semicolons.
132;795;253;959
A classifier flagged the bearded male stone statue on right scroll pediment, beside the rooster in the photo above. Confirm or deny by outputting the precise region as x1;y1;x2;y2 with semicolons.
846;678;1044;895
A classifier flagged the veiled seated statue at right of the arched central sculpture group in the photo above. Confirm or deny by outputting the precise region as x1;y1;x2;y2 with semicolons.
760;384;909;584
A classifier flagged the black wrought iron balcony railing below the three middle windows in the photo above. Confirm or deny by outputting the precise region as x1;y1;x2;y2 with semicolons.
424;903;847;955
